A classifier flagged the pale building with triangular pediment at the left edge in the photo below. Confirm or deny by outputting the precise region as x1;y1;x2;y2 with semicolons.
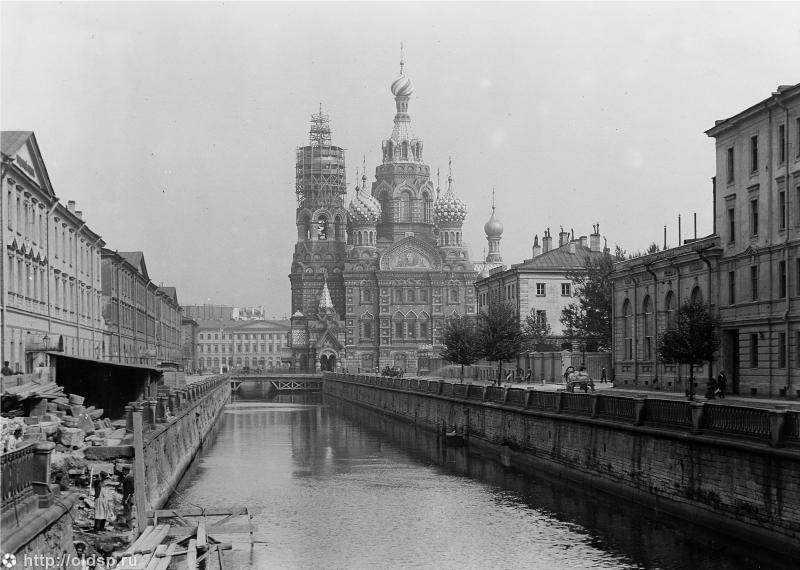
0;131;105;373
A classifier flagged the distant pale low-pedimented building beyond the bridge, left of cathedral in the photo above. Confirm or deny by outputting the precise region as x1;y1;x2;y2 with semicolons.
194;319;289;373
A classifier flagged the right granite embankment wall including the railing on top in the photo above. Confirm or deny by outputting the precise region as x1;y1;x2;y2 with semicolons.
323;373;800;559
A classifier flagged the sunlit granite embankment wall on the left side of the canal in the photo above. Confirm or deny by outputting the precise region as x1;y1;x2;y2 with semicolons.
134;376;231;511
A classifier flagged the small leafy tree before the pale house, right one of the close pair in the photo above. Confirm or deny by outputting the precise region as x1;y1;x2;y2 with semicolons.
478;301;525;384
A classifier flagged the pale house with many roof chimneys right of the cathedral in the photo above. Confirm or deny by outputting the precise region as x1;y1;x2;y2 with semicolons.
475;225;608;345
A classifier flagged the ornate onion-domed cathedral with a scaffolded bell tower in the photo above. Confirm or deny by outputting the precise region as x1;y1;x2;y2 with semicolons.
289;57;478;374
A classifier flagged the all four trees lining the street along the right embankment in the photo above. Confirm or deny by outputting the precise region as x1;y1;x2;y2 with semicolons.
440;248;719;398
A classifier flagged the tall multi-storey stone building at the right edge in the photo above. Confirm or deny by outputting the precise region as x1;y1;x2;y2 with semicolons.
706;84;800;396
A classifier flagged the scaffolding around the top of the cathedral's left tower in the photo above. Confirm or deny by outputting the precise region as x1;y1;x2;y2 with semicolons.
295;105;347;208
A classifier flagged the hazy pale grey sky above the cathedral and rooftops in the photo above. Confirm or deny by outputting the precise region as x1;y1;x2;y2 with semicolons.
0;2;800;317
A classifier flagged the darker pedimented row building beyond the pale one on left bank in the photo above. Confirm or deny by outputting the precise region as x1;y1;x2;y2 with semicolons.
101;249;183;365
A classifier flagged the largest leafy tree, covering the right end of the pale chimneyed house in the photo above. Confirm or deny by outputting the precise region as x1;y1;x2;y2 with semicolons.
561;254;614;350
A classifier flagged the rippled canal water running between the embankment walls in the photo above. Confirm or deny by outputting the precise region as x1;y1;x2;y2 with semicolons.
169;385;791;570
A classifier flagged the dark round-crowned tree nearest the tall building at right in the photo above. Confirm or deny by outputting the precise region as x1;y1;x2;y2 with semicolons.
658;301;720;400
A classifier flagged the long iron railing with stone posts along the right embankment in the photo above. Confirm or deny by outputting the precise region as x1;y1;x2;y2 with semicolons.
326;372;800;449
